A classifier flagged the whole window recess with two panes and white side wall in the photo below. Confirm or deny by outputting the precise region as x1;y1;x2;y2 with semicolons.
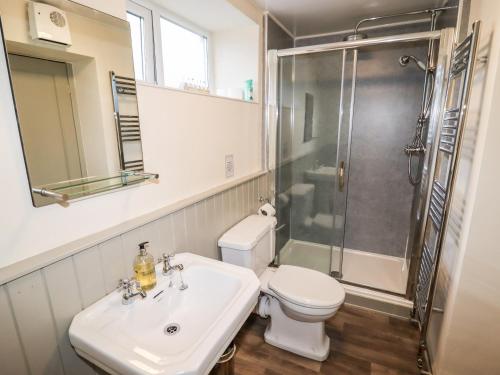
126;0;260;100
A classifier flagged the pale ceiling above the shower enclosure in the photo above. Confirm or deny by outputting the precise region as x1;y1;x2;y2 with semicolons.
253;0;452;36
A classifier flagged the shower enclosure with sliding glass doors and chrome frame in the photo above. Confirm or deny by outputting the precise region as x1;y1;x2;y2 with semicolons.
267;29;452;296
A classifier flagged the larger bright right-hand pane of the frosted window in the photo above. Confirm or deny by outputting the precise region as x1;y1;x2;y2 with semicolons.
160;17;208;88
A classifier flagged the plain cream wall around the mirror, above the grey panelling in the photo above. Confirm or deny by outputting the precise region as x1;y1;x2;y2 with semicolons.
0;1;262;268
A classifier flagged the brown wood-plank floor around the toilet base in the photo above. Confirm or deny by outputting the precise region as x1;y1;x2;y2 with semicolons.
234;306;419;375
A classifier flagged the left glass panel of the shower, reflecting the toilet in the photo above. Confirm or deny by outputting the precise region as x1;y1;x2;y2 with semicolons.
276;51;350;275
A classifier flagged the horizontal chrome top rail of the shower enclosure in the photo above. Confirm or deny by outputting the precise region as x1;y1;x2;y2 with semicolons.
278;31;441;57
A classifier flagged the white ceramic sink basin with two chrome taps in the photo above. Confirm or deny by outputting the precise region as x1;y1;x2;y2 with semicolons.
69;253;260;375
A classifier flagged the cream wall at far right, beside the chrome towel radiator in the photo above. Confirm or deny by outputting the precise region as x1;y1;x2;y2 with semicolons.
434;0;500;375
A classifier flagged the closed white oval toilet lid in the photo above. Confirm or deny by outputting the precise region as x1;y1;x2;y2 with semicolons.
269;265;345;308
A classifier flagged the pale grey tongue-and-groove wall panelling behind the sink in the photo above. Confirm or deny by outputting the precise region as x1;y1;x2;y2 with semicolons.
0;174;269;375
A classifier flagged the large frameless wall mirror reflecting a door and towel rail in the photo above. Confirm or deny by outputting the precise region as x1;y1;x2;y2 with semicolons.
0;0;158;207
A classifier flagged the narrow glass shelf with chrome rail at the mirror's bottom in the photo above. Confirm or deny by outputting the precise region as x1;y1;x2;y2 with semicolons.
32;171;159;202
